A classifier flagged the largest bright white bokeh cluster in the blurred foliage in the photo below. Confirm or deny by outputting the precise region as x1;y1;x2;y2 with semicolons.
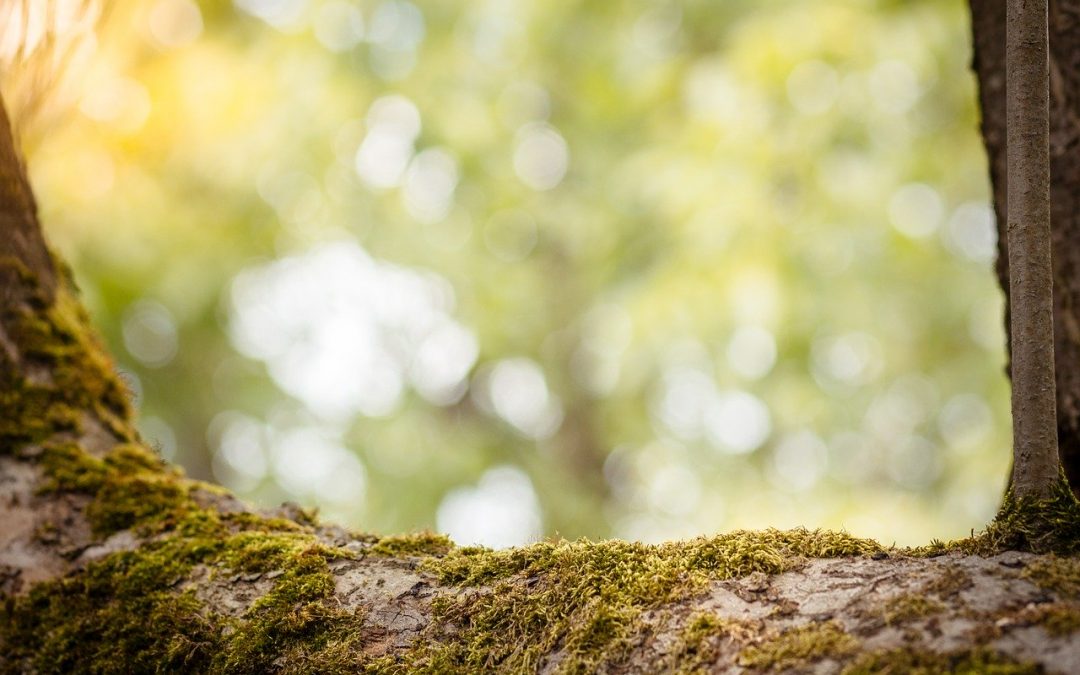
229;243;478;419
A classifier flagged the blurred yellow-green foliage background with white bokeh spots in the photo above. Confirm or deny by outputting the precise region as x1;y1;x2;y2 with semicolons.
10;0;1010;546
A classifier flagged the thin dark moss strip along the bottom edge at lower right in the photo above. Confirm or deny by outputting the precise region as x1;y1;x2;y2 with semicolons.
842;648;1042;675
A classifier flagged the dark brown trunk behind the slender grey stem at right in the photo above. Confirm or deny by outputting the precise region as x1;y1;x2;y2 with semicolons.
971;0;1080;491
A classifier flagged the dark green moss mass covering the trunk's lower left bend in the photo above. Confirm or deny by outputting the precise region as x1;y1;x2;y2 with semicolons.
0;429;375;673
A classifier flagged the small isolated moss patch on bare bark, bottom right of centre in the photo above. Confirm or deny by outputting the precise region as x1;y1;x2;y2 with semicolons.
739;621;859;671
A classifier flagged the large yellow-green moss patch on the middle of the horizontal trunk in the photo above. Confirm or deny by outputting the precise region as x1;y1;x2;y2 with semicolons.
407;529;881;673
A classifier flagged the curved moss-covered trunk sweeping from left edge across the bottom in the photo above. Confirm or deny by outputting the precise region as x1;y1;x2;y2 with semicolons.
0;21;1080;673
